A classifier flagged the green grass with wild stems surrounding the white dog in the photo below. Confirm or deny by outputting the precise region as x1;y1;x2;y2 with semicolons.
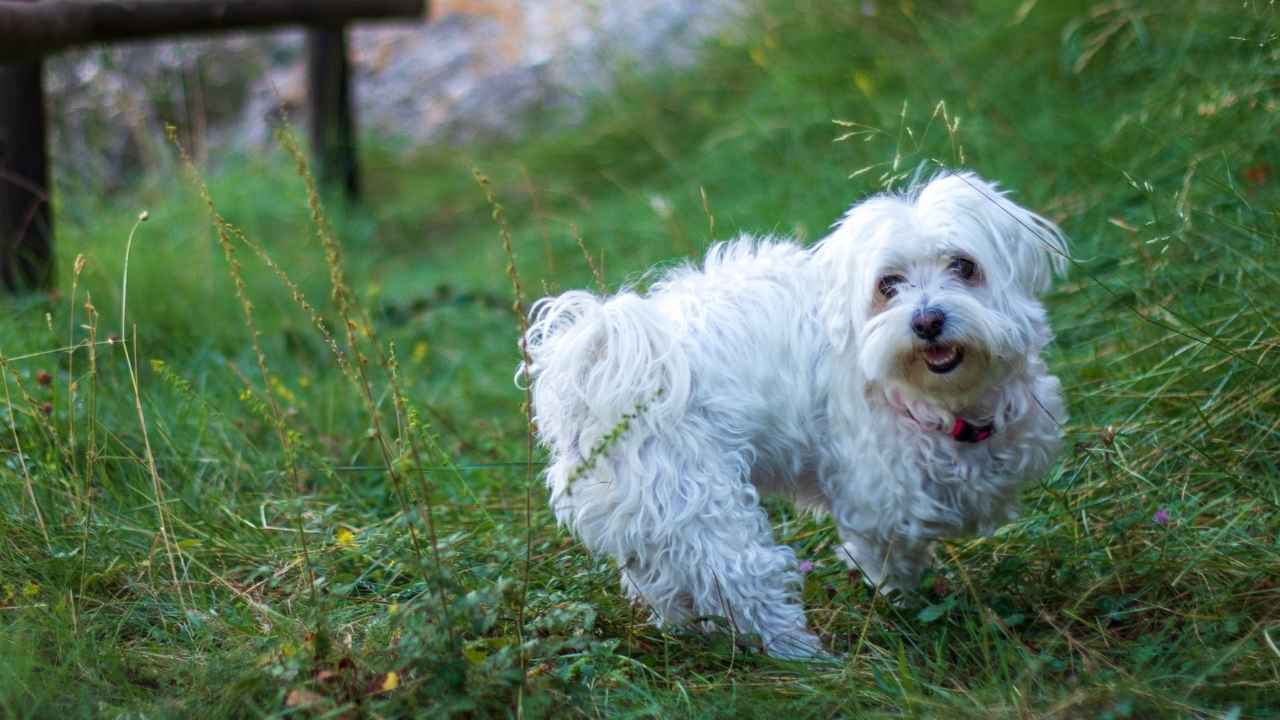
0;0;1280;719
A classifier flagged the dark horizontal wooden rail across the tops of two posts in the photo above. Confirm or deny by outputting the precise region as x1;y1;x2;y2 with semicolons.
0;0;426;63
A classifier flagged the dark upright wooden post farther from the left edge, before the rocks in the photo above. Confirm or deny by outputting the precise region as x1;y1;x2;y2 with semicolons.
307;27;360;200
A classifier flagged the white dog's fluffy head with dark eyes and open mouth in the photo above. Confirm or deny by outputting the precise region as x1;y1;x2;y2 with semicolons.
815;173;1068;407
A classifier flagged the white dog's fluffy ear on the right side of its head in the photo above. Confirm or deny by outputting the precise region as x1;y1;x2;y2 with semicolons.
916;173;1070;296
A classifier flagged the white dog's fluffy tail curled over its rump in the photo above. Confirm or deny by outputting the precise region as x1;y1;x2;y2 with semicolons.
516;291;690;448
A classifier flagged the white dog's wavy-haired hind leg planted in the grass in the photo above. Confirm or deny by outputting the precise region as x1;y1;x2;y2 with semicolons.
547;423;826;657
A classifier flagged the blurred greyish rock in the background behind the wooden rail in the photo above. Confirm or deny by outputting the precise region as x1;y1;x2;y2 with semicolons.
47;0;744;188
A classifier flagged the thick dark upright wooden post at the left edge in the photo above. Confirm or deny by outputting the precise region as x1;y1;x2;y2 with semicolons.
0;60;54;293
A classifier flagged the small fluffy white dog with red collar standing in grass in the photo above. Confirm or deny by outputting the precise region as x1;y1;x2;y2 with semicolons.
517;173;1068;657
